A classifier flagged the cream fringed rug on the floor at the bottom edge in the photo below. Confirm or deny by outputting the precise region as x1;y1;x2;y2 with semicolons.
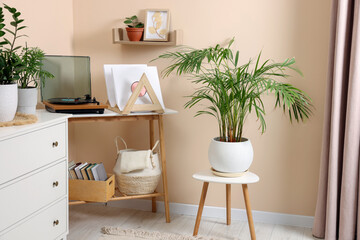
99;227;225;240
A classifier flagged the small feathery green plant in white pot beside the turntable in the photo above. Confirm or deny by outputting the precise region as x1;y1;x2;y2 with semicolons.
17;46;54;114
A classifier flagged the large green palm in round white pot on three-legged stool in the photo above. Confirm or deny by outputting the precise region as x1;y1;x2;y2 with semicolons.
158;39;312;173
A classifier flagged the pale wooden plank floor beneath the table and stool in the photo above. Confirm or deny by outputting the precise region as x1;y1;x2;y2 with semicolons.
68;204;315;240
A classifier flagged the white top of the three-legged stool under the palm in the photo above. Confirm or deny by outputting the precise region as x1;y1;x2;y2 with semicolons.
193;169;260;184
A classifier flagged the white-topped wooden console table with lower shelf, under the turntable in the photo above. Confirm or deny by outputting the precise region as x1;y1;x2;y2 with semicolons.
69;109;177;223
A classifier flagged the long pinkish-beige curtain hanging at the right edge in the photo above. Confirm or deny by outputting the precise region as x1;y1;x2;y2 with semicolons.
313;0;360;240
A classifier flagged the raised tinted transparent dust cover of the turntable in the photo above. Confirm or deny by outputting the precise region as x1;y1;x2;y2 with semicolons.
41;55;91;101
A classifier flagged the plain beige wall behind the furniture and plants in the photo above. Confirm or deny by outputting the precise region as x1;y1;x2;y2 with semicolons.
7;0;330;215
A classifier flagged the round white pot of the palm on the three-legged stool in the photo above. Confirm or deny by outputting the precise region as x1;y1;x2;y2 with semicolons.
208;138;254;173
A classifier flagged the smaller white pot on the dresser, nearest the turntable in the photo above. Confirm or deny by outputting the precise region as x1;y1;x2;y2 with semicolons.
17;87;38;114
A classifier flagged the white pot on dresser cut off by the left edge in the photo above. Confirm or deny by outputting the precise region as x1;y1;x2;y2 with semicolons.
0;83;18;122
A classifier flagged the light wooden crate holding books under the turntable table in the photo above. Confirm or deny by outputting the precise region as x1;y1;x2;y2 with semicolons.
69;174;115;202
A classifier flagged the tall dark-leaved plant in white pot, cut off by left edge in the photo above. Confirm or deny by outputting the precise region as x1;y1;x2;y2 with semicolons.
0;4;26;122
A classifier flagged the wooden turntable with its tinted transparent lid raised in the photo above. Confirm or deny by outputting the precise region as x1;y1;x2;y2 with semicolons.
41;55;107;114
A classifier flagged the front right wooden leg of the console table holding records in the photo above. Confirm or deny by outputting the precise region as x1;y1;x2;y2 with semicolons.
158;115;170;223
